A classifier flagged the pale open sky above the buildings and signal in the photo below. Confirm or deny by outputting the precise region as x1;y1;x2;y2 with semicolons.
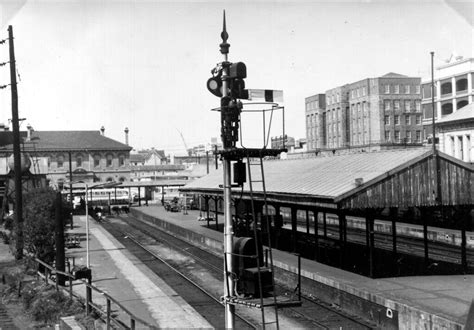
0;0;473;154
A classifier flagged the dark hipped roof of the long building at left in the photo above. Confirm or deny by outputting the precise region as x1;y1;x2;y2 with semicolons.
0;131;132;151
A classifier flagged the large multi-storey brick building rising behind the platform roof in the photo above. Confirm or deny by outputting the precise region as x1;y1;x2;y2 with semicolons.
306;73;422;150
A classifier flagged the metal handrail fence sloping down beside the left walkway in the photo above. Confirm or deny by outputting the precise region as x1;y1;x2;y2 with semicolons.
33;258;156;329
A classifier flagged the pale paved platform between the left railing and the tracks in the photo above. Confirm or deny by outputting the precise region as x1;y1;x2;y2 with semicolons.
66;216;211;328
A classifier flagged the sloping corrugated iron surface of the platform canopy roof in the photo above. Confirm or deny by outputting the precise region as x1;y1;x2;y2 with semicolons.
184;148;430;198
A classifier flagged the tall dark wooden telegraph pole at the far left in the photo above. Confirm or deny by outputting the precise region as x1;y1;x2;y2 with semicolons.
8;25;23;260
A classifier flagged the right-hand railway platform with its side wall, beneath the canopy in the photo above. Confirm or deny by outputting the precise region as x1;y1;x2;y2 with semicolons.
131;206;474;329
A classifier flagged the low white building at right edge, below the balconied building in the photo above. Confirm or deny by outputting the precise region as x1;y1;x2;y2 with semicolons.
436;103;474;163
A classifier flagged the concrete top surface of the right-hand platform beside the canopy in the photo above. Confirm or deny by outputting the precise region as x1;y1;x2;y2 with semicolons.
133;206;474;329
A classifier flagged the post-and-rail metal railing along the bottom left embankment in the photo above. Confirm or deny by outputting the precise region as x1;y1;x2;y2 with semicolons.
33;258;156;329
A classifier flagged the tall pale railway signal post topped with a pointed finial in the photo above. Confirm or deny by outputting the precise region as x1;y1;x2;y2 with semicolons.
216;11;235;329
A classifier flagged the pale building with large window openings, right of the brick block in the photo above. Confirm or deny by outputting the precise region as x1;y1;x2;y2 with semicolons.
422;54;474;138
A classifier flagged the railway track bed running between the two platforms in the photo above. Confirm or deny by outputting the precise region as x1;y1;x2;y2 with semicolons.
103;216;372;329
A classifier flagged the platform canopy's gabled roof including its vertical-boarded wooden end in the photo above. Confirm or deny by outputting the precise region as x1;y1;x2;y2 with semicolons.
182;148;473;207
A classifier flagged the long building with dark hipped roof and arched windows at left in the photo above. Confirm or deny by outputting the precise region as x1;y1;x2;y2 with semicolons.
0;125;132;187
